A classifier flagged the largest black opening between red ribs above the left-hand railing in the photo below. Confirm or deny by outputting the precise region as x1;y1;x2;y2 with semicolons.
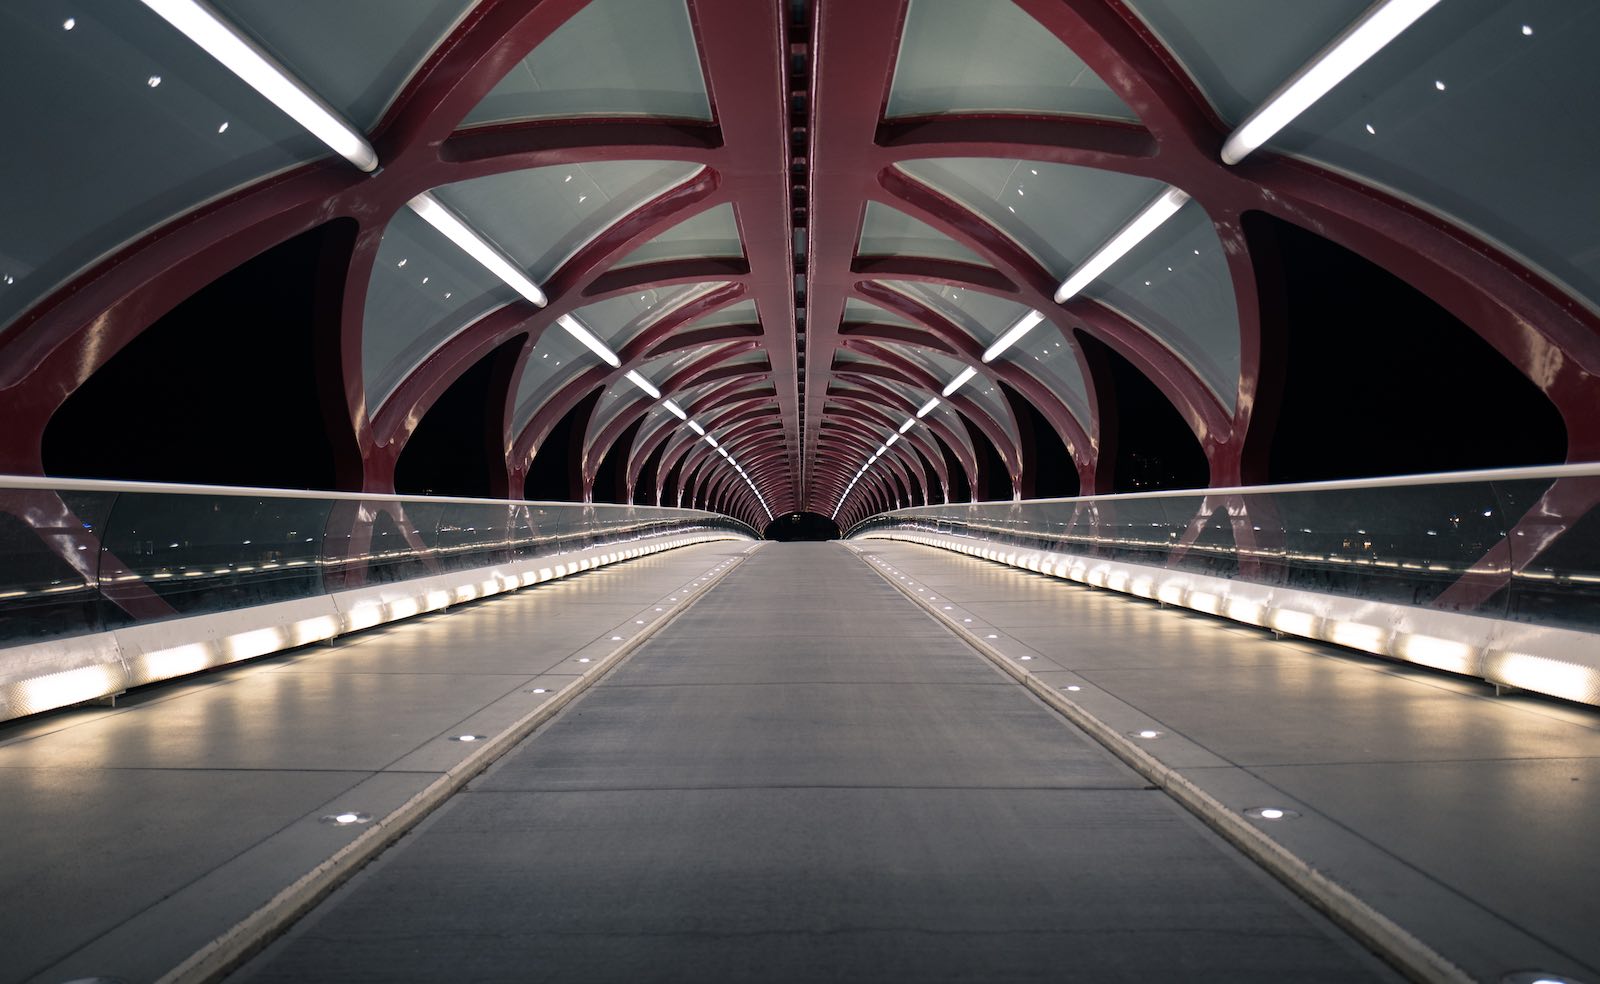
42;219;362;490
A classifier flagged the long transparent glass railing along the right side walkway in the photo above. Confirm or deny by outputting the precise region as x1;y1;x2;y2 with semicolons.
858;475;1600;632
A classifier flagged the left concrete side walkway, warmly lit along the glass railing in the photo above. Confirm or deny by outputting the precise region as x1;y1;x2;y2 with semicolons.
0;542;752;984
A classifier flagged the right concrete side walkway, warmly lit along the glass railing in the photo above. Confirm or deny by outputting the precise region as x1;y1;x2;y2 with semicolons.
854;539;1600;981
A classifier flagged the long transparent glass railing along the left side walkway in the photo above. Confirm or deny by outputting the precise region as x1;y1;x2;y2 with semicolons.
0;488;746;646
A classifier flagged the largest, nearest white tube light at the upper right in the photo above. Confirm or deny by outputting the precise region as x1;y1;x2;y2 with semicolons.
1222;0;1438;163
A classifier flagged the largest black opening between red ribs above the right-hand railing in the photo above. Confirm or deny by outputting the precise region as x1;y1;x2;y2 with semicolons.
1245;213;1566;482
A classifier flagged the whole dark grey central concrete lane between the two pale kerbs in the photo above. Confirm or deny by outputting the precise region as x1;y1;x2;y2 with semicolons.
235;544;1394;982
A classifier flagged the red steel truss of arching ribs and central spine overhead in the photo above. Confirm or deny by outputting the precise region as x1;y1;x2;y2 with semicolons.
0;0;1600;537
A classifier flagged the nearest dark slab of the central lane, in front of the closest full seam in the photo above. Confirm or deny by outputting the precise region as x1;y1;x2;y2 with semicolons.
235;784;1392;984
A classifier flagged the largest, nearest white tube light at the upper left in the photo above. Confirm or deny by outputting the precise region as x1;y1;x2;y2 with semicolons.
144;0;378;171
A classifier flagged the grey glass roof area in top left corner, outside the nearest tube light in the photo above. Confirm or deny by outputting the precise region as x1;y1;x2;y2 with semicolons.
0;0;326;326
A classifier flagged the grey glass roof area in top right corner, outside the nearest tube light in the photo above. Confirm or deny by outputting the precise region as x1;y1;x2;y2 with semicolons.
1269;0;1600;309
